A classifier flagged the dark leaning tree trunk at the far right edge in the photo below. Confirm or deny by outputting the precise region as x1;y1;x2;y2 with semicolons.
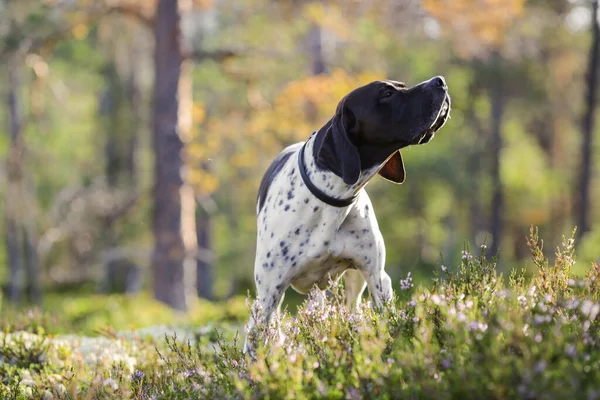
575;0;600;238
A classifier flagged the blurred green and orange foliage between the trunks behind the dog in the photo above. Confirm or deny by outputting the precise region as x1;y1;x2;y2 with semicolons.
0;0;600;297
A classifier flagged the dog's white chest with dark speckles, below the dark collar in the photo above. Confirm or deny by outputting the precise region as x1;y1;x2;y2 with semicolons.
256;146;376;293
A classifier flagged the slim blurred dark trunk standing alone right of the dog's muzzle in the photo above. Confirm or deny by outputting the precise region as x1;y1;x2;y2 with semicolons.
488;61;505;256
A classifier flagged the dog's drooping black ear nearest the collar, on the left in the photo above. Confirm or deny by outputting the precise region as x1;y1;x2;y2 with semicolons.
317;102;361;185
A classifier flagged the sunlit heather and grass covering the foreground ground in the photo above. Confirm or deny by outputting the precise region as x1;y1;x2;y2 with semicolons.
0;230;600;399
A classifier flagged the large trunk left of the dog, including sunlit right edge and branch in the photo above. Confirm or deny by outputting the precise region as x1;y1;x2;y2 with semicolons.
152;0;235;310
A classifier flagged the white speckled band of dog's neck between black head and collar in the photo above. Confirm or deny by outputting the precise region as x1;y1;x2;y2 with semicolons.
304;130;379;199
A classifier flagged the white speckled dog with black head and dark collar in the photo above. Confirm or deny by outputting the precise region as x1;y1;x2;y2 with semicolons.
244;76;450;353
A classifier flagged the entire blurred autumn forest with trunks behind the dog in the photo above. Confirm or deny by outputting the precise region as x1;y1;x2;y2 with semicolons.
0;0;600;318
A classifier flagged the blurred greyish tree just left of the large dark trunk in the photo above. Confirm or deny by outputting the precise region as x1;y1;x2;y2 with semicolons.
98;15;151;292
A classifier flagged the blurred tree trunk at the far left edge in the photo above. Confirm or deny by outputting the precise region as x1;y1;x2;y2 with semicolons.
0;2;58;304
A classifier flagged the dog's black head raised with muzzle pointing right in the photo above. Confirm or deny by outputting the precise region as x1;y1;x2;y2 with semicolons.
315;76;450;185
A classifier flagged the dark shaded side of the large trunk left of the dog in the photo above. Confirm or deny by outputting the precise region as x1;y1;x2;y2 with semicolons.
152;0;187;310
